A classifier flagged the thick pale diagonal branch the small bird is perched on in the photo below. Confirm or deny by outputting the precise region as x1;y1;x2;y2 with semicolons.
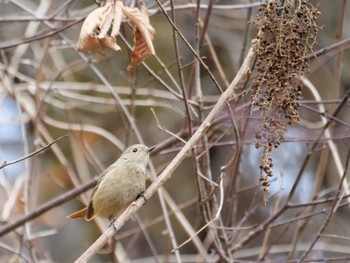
75;48;255;263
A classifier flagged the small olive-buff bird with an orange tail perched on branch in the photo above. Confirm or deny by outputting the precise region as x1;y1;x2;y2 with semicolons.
67;144;155;222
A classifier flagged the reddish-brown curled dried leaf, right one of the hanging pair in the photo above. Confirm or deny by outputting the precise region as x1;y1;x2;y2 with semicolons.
122;5;156;71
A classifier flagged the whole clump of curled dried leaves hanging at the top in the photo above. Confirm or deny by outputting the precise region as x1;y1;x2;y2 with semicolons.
76;1;155;70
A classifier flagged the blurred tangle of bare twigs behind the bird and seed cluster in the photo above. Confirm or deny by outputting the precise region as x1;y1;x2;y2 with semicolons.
0;0;350;262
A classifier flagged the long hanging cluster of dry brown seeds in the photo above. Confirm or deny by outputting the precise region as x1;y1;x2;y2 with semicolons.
251;0;320;202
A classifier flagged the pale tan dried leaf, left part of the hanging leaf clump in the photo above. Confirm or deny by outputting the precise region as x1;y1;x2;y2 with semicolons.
76;3;121;52
